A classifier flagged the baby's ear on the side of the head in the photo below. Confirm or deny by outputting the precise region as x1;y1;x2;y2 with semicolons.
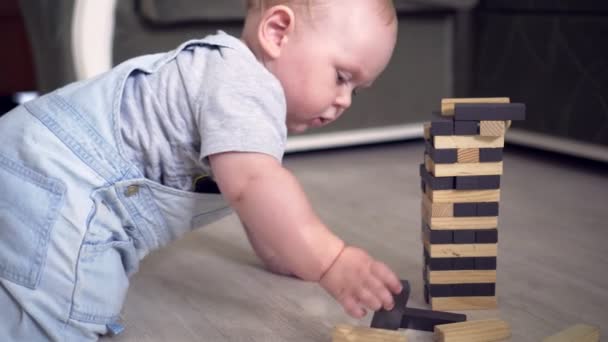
258;5;295;59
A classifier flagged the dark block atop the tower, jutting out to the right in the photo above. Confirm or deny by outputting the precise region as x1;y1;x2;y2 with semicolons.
454;103;526;121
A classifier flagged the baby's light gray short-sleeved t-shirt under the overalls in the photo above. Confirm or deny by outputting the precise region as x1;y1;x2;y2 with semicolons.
121;32;287;190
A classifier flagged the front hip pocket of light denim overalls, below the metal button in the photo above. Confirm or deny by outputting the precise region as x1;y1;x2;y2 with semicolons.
71;188;139;324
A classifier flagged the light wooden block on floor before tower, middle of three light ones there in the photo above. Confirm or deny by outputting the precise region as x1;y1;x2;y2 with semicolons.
435;319;511;342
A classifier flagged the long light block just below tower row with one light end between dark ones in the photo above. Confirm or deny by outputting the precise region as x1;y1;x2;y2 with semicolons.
424;155;503;177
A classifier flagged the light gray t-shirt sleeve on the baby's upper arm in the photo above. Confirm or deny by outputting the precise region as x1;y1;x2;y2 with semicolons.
195;48;287;163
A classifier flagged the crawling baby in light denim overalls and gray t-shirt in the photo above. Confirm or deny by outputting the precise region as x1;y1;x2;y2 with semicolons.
0;0;401;341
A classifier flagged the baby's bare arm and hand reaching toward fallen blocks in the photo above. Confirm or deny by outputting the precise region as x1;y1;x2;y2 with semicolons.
209;152;401;317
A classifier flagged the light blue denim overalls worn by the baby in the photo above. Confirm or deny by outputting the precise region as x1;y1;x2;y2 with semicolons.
0;41;230;341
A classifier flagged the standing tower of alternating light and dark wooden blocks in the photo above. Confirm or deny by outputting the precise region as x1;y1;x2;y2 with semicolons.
420;98;526;310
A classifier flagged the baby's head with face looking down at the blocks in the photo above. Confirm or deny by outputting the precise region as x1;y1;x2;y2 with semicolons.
243;0;397;132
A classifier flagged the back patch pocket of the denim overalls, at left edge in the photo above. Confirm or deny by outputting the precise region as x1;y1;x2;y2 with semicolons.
0;154;65;289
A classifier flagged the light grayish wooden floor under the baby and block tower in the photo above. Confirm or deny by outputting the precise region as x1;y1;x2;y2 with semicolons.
104;142;608;342
